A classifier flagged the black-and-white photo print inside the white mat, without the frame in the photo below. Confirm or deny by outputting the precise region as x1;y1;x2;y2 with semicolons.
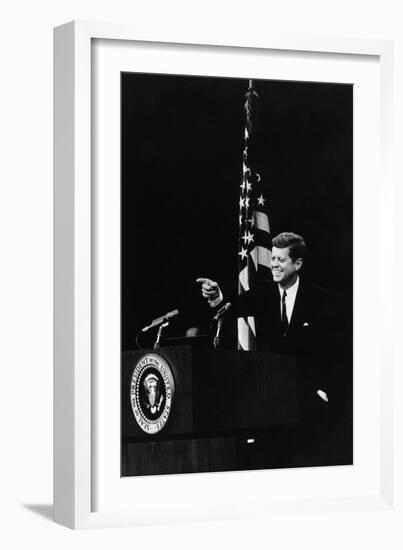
121;73;353;476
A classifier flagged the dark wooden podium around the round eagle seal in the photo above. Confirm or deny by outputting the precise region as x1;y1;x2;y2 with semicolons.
121;345;298;476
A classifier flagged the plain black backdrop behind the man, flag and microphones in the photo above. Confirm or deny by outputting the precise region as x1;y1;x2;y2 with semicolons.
121;73;353;350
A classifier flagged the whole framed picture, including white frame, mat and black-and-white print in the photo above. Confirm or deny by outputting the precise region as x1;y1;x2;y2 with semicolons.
55;23;393;528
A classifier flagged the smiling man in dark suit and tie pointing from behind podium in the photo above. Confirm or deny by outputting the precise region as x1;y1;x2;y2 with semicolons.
197;233;348;465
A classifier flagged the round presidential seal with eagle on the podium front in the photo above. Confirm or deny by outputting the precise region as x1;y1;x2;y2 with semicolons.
130;353;175;434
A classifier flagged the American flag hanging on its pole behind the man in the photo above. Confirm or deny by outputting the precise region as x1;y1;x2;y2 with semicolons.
238;80;271;351
